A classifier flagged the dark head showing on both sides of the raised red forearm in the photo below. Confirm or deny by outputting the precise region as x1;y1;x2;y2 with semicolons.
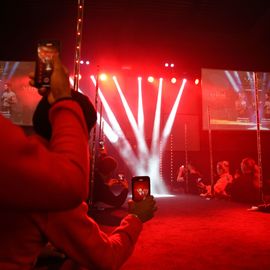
32;90;97;140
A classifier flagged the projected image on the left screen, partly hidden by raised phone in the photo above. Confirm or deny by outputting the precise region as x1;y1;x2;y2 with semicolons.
0;61;40;126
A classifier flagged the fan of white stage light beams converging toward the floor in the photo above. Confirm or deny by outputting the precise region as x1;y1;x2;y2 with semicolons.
88;76;186;195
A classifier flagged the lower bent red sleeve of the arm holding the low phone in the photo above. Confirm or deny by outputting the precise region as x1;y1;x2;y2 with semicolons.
36;203;142;269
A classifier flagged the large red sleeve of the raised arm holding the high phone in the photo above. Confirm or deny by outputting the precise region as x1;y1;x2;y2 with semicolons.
0;100;89;210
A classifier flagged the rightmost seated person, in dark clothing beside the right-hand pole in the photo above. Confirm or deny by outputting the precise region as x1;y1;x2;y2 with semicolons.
228;157;260;204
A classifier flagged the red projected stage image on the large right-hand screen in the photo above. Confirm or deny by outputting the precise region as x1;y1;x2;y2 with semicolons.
202;69;270;130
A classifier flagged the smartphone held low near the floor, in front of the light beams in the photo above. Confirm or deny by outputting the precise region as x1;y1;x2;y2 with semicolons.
131;176;150;201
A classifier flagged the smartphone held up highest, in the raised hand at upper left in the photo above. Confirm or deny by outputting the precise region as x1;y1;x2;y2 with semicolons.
35;40;60;88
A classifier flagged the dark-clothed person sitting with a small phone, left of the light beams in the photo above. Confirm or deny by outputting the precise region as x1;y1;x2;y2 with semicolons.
93;156;128;208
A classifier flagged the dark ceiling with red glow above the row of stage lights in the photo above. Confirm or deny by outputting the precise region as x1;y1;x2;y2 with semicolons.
0;0;270;71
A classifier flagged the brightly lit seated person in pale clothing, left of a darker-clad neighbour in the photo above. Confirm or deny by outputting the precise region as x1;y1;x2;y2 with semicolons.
201;160;233;198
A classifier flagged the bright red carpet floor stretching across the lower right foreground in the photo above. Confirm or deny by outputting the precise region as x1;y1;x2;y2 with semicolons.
92;195;270;270
